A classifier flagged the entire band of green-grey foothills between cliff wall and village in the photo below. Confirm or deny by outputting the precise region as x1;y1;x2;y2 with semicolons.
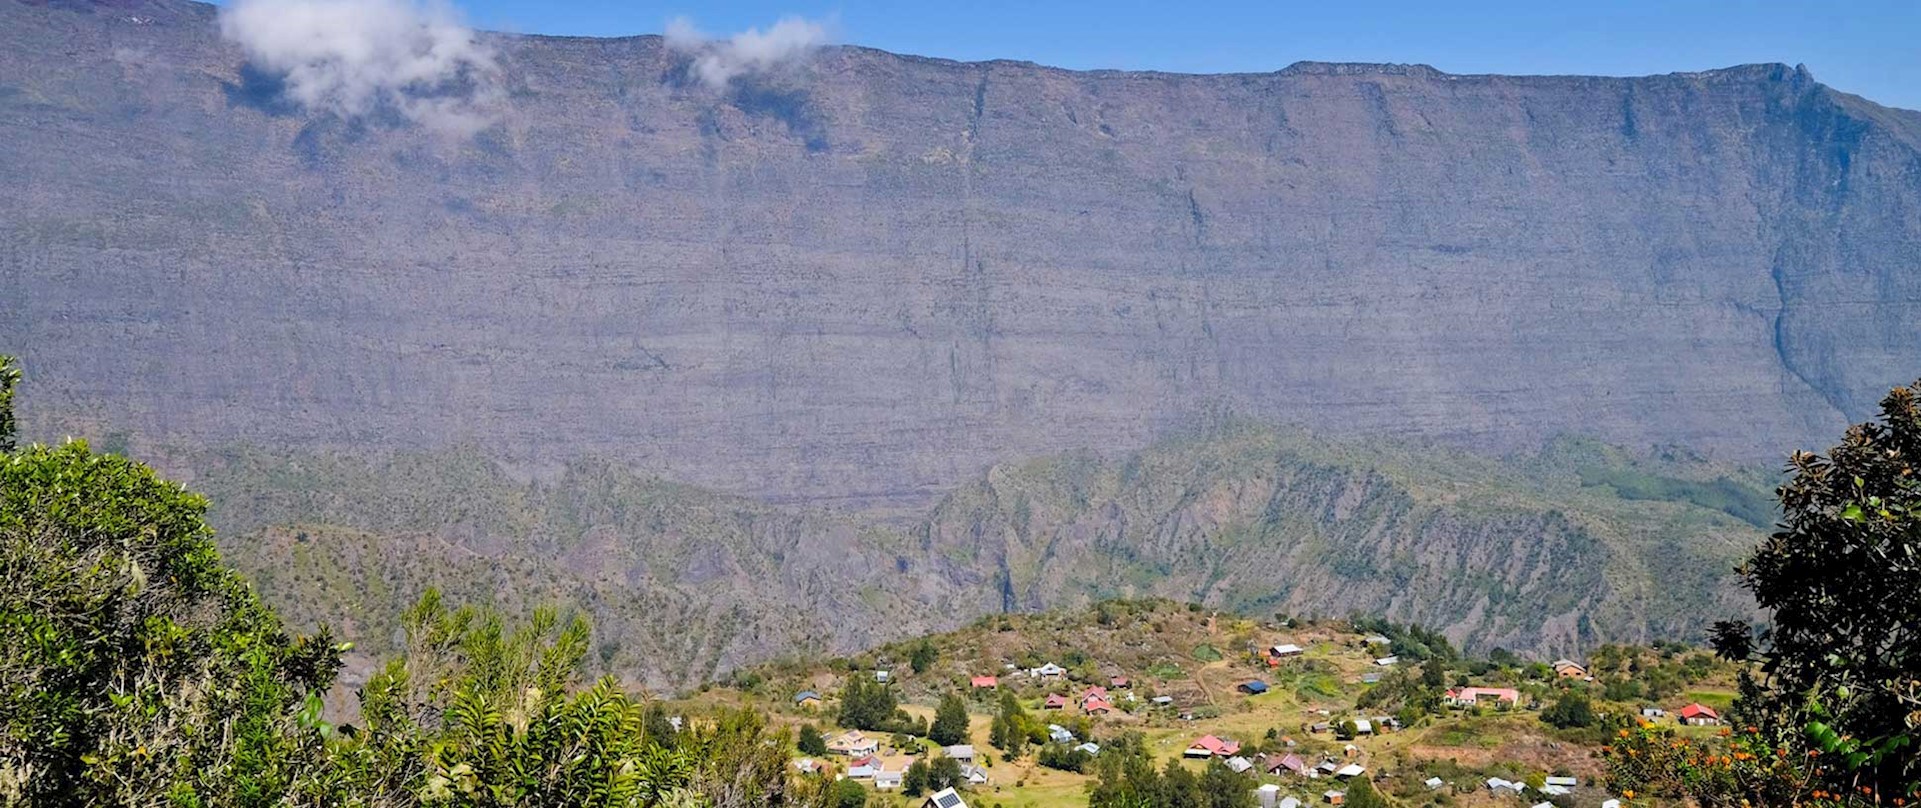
192;424;1765;687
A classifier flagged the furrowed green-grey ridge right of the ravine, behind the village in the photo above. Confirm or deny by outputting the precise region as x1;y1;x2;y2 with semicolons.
926;426;1767;651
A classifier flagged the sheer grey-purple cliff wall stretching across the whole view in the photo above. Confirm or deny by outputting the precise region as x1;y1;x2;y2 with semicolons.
0;0;1921;501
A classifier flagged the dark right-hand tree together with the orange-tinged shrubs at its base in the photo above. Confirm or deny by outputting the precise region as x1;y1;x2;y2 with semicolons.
1608;382;1921;806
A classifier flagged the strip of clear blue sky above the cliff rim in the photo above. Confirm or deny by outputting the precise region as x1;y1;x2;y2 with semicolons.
455;0;1921;109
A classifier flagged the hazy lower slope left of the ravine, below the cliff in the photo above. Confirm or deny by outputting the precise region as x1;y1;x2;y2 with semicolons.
196;449;939;687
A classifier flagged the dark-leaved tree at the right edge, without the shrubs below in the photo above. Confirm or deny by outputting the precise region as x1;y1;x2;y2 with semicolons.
1714;382;1921;800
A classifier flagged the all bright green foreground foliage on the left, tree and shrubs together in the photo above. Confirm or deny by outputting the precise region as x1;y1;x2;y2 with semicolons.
0;357;818;808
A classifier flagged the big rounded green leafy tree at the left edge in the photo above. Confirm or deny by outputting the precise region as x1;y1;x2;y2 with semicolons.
0;433;340;806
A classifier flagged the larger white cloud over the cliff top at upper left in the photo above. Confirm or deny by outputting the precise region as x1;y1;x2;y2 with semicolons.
221;0;501;136
